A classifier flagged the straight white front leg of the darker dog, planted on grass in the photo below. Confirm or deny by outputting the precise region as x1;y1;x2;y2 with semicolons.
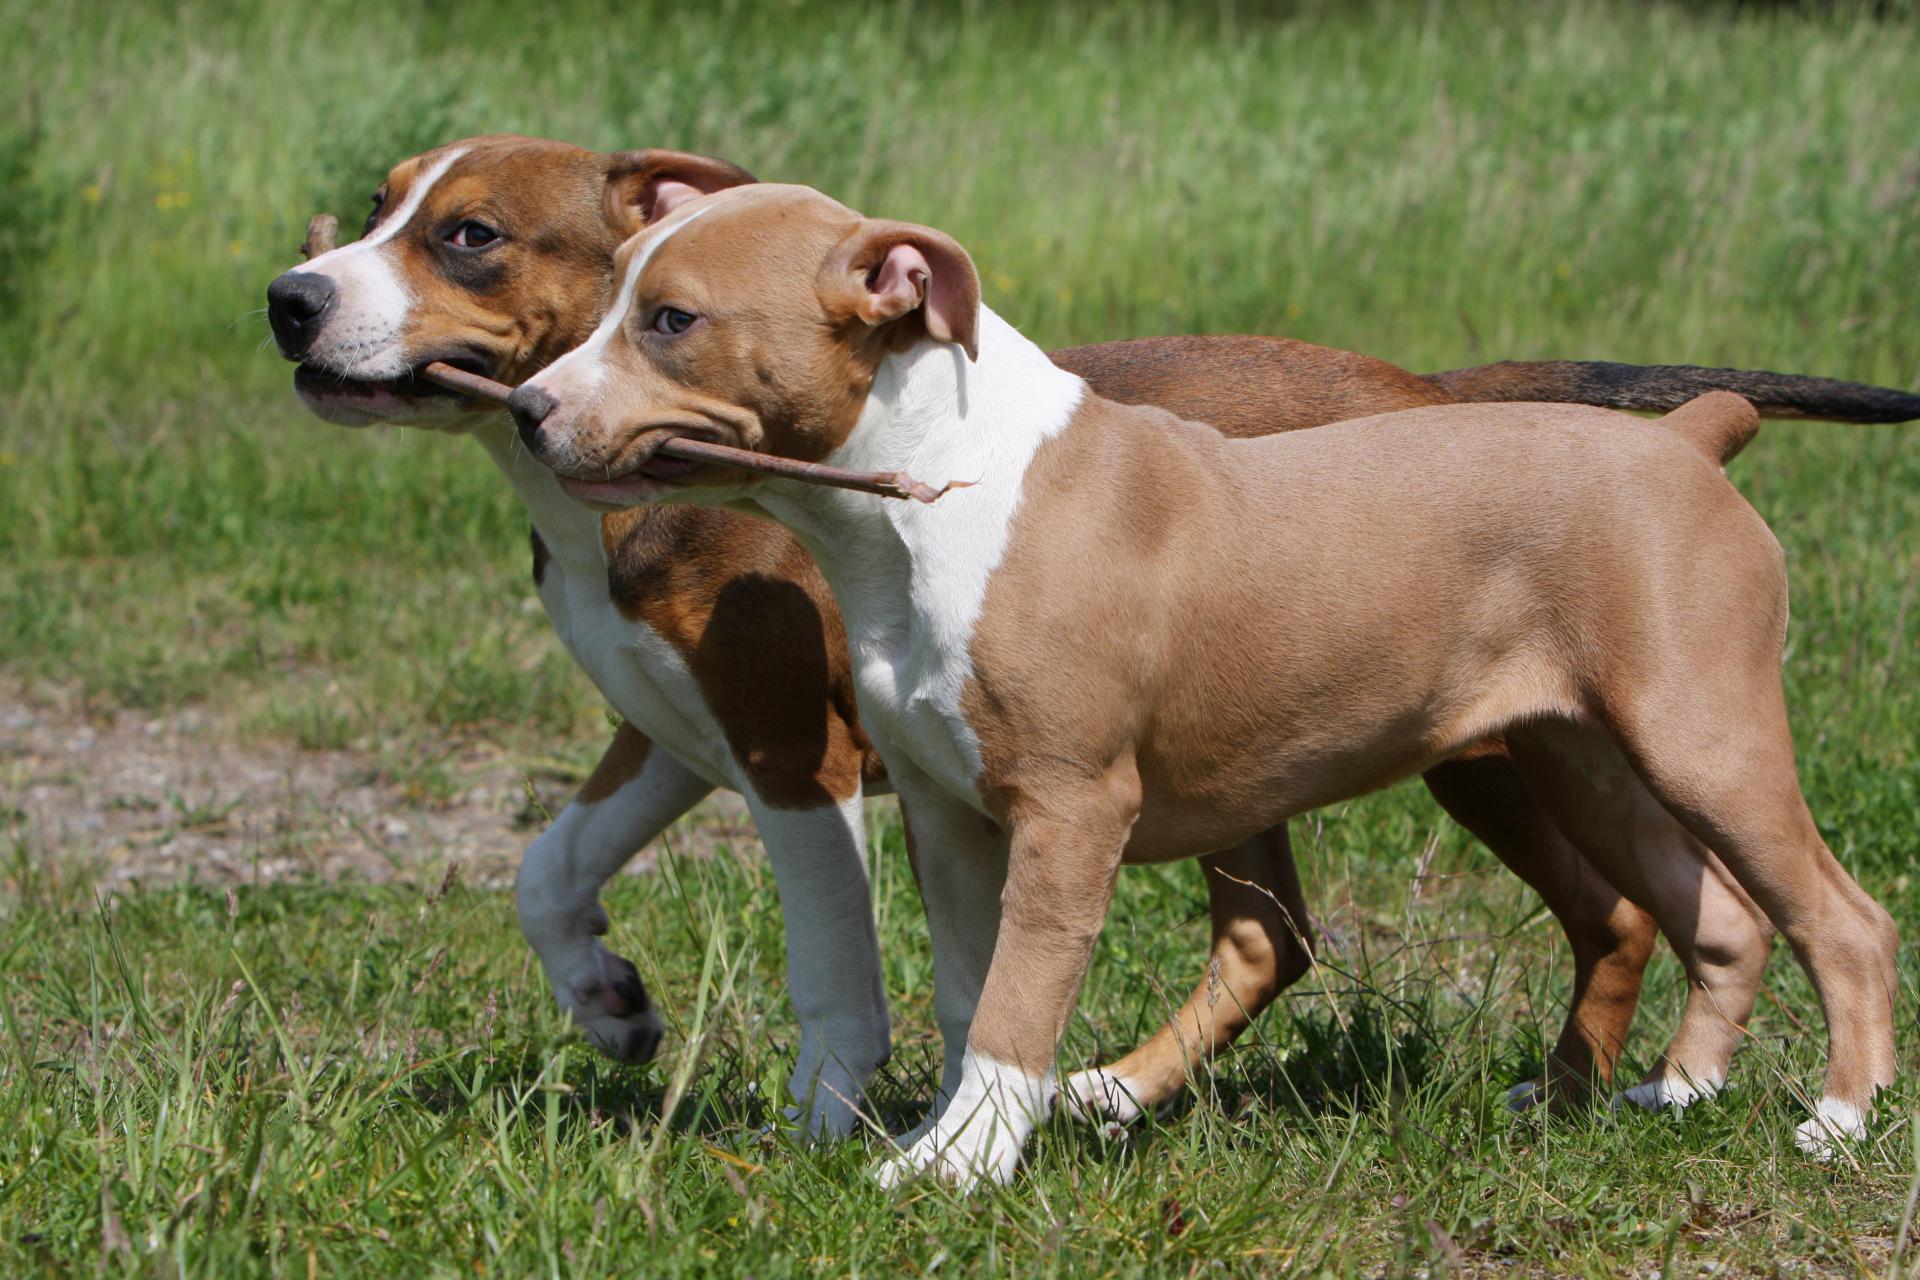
747;787;893;1138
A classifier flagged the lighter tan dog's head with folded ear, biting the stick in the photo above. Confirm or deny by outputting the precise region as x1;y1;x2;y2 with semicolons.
509;182;979;507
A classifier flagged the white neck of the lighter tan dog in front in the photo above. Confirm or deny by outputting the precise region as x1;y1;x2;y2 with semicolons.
732;307;1091;649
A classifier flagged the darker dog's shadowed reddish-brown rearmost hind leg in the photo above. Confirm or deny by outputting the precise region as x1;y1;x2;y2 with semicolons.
1425;748;1659;1109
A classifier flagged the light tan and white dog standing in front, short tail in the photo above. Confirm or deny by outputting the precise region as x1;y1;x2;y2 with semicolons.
511;184;1895;1182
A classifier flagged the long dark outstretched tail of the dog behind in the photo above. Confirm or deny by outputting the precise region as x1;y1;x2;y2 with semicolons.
1425;361;1920;422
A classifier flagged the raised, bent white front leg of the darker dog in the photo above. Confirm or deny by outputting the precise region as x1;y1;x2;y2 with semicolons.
515;725;712;1061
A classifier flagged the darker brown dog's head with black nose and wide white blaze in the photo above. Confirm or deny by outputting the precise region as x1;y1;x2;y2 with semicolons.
267;136;753;426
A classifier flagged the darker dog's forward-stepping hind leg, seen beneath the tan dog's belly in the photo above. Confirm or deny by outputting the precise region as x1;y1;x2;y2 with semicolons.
1062;827;1313;1125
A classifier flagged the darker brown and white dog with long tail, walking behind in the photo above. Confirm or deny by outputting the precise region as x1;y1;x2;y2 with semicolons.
269;136;1920;1132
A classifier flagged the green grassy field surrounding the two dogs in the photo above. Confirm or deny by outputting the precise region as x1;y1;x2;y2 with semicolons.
0;0;1920;1278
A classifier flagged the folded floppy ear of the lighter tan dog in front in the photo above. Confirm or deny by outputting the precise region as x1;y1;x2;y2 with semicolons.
820;219;979;361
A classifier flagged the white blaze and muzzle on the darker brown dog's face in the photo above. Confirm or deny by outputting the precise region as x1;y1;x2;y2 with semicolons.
300;148;467;382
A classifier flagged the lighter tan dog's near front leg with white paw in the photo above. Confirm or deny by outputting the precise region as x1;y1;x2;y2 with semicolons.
879;771;1139;1188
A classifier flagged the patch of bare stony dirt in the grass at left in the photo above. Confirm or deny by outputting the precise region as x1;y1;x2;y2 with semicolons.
0;679;755;889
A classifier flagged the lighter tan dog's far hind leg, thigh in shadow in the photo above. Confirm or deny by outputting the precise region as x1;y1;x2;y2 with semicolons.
1509;725;1772;1107
